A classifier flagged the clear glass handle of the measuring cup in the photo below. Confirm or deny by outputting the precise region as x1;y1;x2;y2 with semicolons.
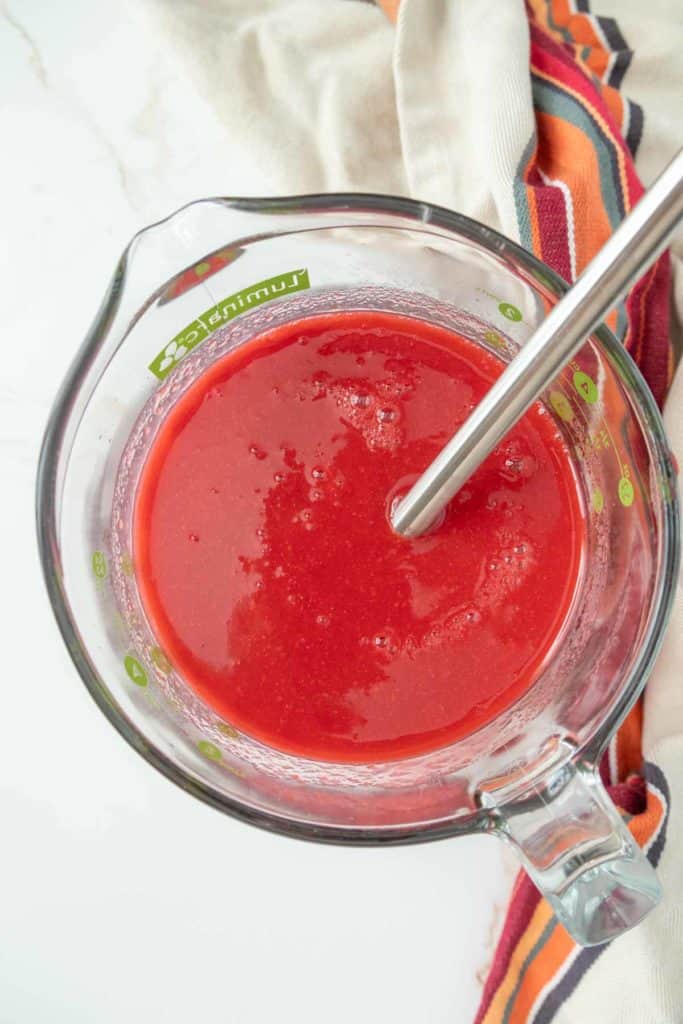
498;764;661;946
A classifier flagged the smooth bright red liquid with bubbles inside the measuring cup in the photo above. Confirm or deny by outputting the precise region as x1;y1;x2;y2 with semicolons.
134;312;584;762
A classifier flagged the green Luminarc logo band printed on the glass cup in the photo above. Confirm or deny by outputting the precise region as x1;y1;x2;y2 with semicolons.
148;268;310;381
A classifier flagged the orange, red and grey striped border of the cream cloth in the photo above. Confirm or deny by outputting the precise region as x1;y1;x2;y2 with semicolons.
379;0;683;1024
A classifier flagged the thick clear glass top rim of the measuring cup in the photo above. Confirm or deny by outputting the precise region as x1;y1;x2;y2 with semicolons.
36;193;680;846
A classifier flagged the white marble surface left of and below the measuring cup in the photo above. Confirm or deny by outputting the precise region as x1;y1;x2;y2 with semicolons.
0;0;510;1024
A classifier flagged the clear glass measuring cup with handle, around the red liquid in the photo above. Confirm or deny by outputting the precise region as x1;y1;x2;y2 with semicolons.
38;196;679;944
